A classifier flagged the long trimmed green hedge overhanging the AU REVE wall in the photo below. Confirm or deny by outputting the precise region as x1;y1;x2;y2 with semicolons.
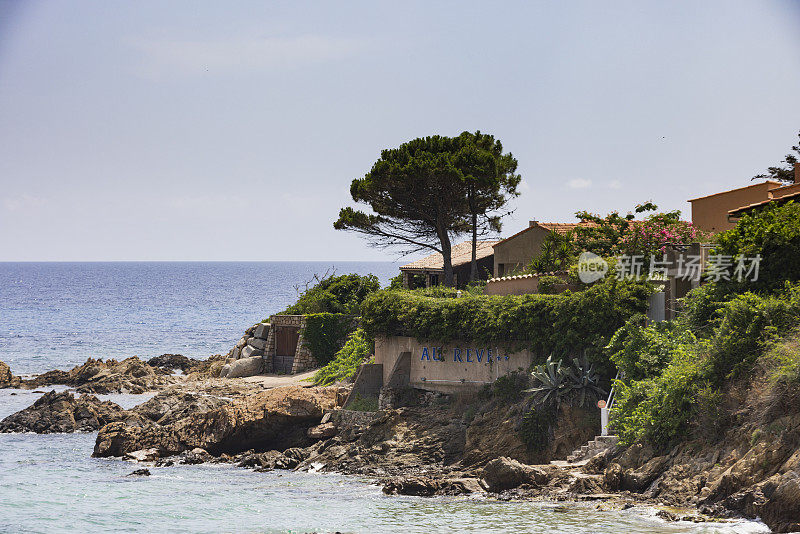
362;278;651;366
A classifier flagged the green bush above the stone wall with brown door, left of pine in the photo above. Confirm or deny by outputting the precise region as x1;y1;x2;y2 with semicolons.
281;274;380;315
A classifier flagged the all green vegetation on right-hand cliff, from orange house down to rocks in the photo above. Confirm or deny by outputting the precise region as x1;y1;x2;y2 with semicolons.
608;203;800;448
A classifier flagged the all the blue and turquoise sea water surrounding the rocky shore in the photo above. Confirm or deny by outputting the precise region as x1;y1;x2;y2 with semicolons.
0;262;768;534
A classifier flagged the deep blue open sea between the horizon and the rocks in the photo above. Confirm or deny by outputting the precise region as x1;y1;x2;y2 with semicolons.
0;261;399;374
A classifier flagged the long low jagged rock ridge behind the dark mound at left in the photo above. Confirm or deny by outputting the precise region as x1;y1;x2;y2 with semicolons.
21;356;175;394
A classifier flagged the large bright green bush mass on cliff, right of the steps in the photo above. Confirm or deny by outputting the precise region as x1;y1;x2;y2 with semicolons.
609;285;800;447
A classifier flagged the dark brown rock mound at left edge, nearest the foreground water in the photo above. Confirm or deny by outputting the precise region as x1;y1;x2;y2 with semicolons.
0;391;138;434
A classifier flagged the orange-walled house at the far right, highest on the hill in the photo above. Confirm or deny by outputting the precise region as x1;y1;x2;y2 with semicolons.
689;163;800;233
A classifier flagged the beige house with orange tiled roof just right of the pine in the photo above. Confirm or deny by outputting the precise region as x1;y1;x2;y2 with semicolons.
494;221;590;278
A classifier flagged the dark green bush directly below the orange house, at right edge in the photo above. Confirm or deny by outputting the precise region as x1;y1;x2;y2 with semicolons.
714;201;800;291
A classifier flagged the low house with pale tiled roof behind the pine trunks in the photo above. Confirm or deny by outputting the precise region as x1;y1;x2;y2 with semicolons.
400;241;497;289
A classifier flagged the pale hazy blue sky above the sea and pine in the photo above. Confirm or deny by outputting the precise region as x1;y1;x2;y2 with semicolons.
0;0;800;261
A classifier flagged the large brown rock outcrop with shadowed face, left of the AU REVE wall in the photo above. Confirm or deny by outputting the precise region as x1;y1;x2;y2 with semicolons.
94;386;338;456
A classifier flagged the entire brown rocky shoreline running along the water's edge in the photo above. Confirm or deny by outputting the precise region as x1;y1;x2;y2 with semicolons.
0;355;800;532
